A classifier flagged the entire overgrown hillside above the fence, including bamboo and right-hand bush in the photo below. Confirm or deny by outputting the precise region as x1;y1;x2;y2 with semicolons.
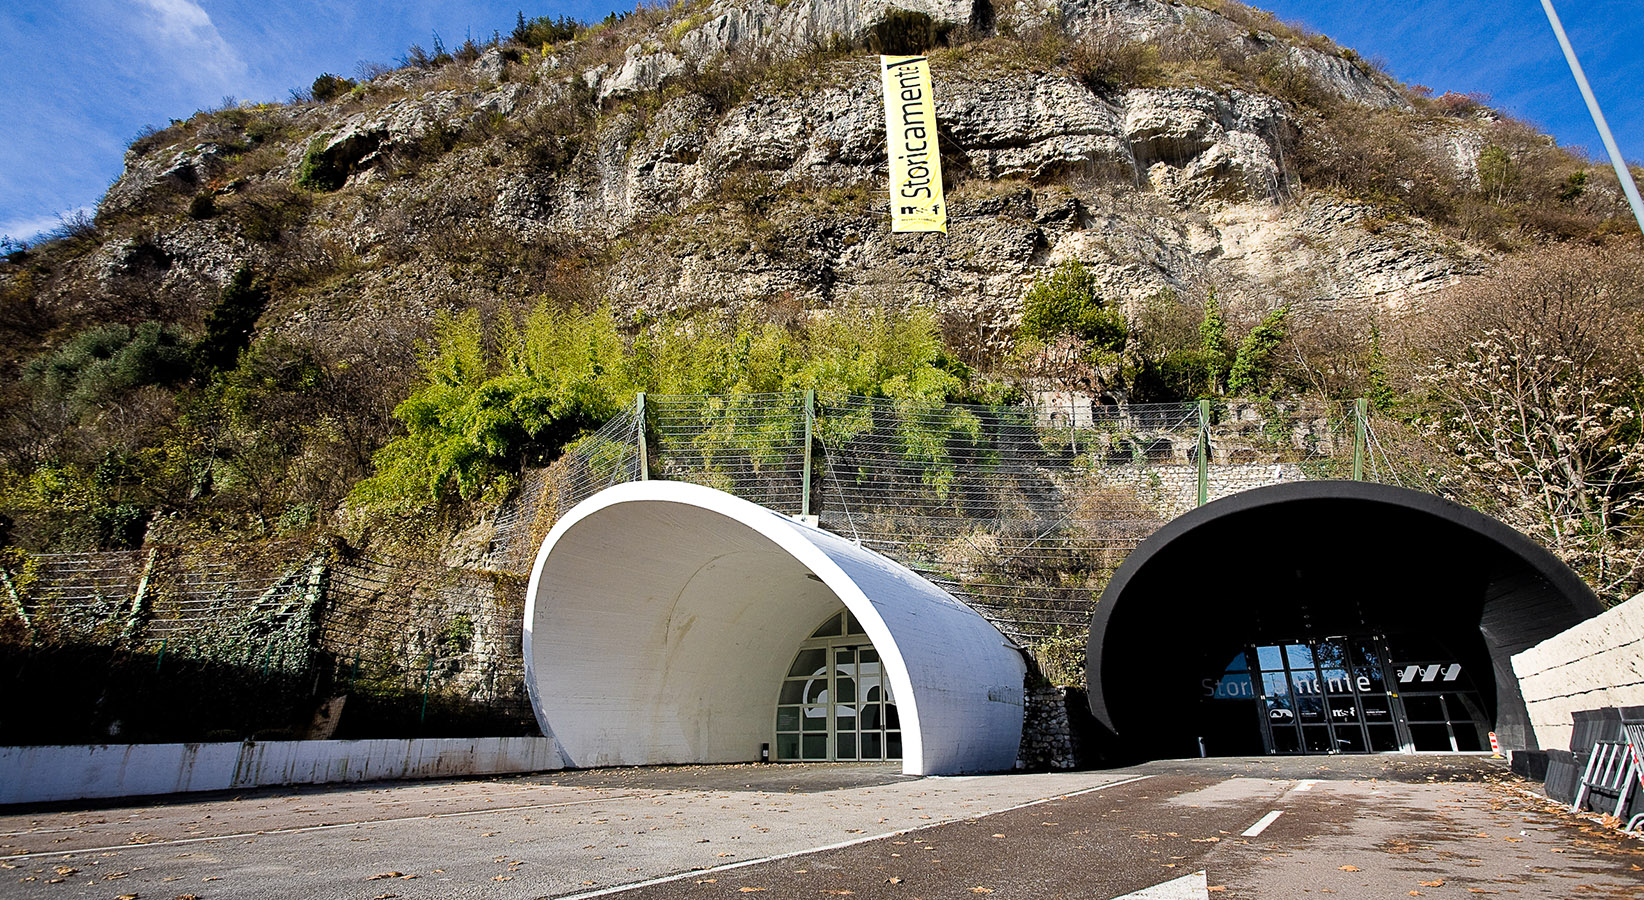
0;0;1644;605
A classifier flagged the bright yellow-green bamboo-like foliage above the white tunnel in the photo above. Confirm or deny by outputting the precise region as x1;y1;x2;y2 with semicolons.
352;304;986;510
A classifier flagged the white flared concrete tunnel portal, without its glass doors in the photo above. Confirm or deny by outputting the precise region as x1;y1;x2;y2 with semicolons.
524;480;1026;775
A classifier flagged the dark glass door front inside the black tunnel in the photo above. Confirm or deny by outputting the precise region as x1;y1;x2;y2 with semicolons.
1202;635;1489;755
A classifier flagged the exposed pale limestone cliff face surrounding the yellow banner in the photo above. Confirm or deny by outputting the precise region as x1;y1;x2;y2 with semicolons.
86;0;1483;352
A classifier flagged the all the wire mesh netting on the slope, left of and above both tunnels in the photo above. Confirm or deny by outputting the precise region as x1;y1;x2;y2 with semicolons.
5;392;1489;734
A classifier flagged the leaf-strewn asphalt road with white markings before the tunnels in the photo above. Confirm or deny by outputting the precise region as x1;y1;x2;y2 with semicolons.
0;757;1644;900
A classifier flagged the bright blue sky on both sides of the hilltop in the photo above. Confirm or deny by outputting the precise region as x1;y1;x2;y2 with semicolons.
0;0;1644;239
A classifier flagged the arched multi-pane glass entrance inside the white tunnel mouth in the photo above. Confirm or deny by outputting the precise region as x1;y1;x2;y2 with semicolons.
774;612;903;762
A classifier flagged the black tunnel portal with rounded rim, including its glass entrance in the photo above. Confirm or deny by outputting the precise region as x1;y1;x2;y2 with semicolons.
1087;482;1600;759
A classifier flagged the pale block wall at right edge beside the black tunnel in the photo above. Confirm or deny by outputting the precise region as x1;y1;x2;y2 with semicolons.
1512;594;1644;750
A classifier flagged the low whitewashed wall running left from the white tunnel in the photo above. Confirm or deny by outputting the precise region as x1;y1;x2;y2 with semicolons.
0;737;564;803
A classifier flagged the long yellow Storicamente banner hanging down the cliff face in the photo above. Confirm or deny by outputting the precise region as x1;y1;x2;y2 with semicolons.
880;56;947;234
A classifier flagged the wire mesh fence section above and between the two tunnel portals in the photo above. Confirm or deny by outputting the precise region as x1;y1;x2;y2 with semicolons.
506;392;1363;664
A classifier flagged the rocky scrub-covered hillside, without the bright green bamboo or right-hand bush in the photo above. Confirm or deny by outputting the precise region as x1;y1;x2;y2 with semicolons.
0;0;1631;546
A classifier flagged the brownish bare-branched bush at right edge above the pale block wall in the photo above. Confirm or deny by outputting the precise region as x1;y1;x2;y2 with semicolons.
1417;248;1644;601
